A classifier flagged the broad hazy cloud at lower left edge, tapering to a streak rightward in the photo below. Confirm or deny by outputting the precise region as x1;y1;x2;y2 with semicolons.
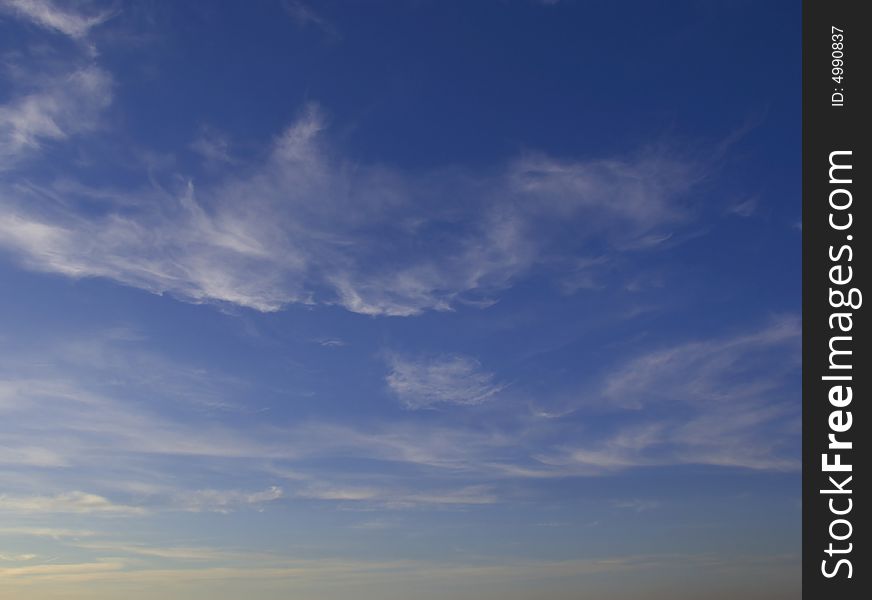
0;330;500;470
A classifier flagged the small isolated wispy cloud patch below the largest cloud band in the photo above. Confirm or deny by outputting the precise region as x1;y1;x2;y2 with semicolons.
385;355;505;409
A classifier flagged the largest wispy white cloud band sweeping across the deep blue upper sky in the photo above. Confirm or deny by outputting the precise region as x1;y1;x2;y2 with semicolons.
0;106;692;316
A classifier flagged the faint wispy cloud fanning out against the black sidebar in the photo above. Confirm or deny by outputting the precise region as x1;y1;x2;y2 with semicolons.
538;317;801;474
